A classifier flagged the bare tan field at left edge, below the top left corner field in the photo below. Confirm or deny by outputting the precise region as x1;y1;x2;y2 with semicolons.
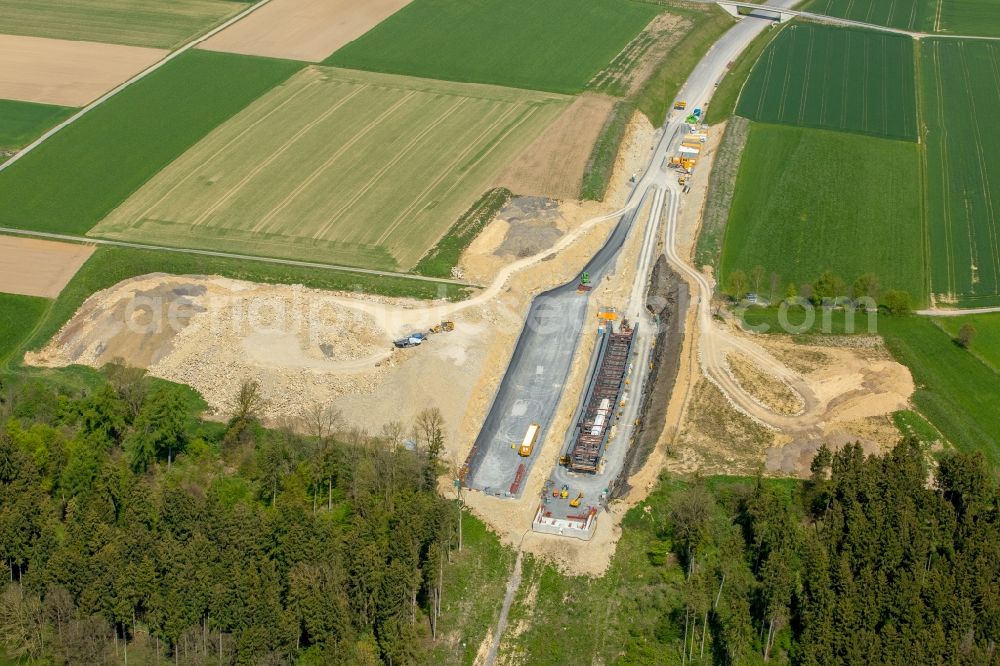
0;35;167;106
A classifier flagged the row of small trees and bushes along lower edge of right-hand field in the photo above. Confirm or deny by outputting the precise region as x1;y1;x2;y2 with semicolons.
726;266;912;314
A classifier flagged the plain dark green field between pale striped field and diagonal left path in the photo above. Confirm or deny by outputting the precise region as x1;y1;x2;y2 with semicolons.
0;51;302;239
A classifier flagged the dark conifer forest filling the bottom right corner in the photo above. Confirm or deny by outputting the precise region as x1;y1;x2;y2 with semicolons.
662;441;1000;666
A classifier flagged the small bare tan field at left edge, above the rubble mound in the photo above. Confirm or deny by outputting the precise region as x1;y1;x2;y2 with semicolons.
0;236;94;298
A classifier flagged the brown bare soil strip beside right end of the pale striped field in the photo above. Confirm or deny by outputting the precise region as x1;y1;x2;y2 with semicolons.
496;94;615;199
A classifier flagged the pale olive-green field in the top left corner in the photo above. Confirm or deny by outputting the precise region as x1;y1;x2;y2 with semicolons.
0;0;247;48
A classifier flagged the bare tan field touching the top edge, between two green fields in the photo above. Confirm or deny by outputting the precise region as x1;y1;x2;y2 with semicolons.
198;0;410;62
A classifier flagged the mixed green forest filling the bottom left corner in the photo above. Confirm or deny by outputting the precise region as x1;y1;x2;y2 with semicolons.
0;366;460;665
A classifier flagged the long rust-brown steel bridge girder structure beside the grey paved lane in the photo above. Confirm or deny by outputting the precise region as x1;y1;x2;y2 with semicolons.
567;319;635;473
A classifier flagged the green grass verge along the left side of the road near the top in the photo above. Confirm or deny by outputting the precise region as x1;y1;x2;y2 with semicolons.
635;5;733;127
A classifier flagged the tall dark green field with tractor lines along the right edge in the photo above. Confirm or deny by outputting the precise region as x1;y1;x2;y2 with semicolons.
921;39;1000;307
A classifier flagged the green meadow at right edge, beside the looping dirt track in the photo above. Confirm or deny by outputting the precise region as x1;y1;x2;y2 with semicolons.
879;317;1000;469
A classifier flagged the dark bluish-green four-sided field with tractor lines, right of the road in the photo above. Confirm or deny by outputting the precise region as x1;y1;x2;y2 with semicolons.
736;24;917;141
